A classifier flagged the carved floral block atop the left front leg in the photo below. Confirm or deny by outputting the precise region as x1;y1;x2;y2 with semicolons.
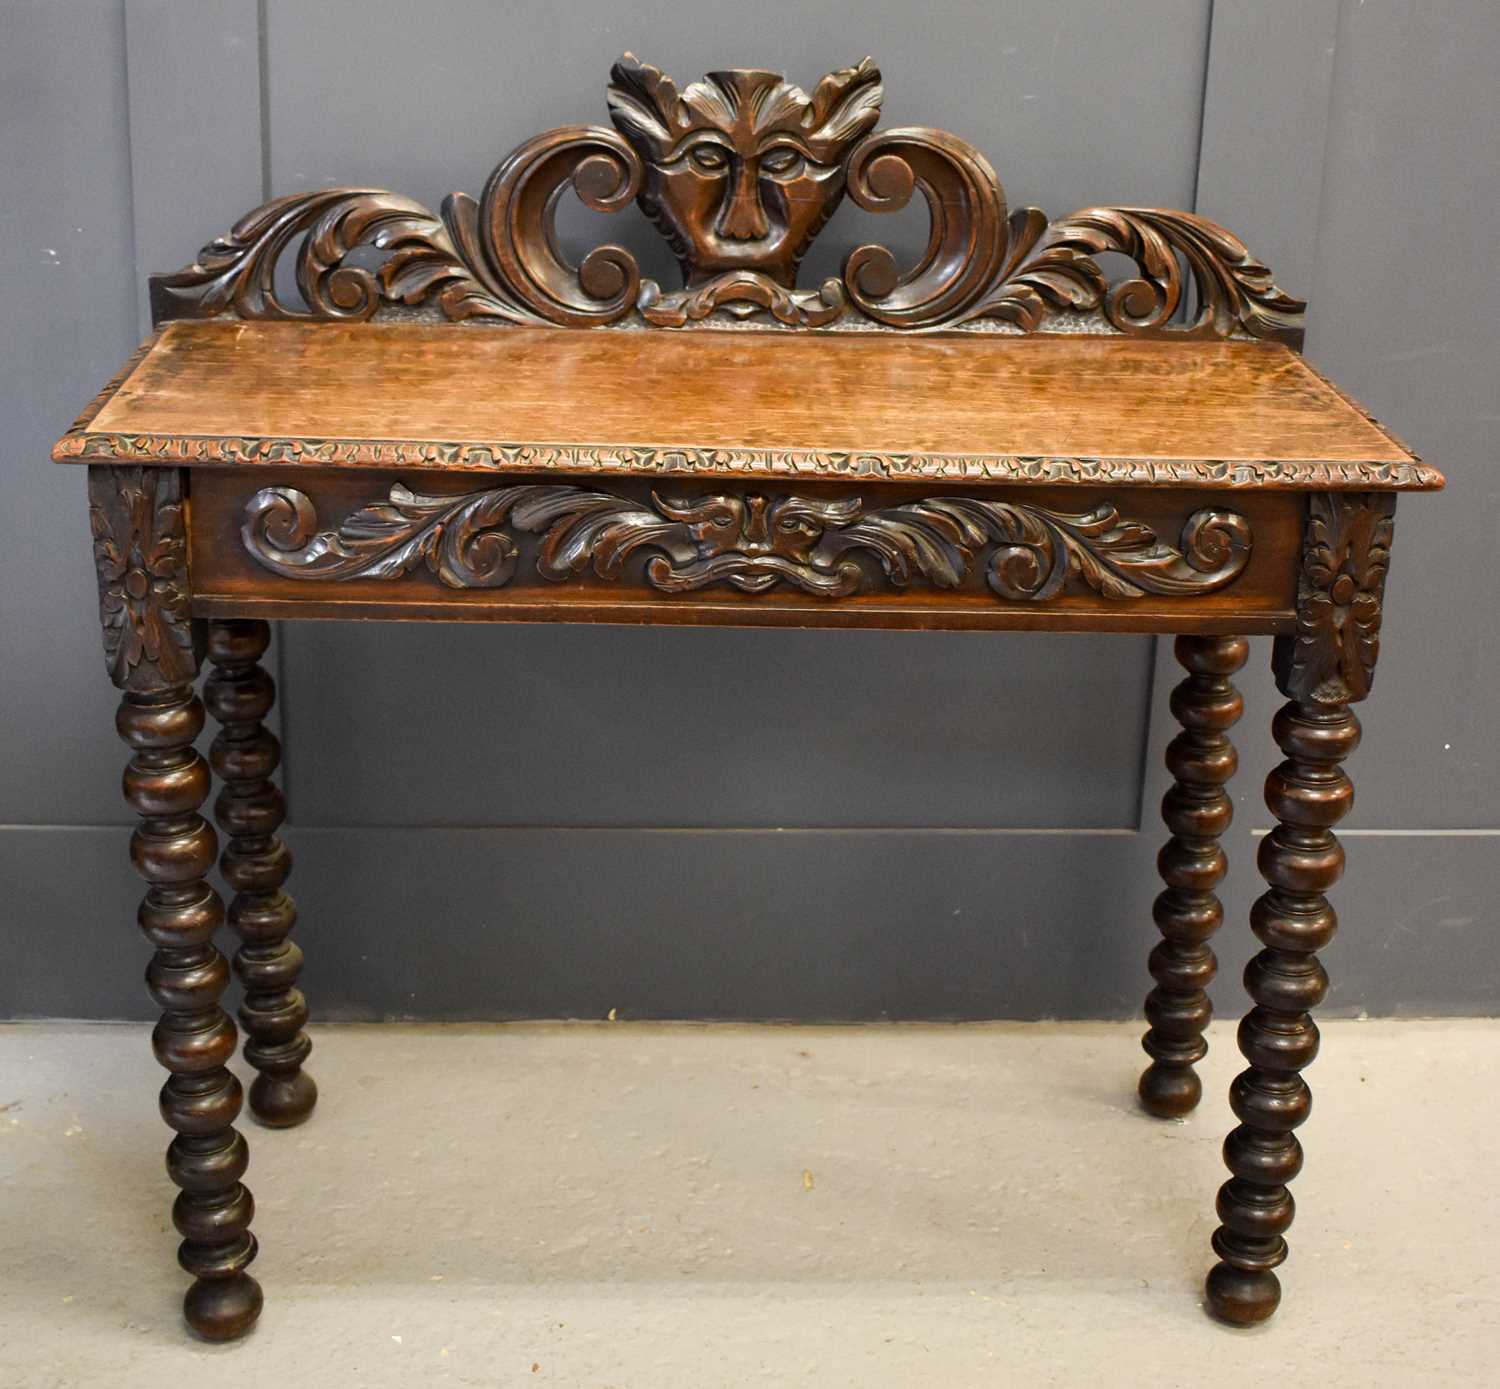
89;467;201;690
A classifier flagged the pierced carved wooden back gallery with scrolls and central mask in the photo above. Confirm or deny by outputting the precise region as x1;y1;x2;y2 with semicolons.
152;54;1305;347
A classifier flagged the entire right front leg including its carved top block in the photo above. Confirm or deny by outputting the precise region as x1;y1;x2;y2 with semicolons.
1208;494;1395;1326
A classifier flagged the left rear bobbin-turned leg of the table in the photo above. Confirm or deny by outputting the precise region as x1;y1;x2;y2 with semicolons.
204;620;318;1128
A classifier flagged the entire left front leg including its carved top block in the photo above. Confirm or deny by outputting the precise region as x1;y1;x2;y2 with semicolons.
89;465;261;1341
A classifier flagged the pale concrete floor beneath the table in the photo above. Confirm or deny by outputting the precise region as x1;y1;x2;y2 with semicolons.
0;1022;1500;1389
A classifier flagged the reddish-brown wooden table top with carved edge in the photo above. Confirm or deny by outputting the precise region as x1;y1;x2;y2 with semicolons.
54;320;1443;489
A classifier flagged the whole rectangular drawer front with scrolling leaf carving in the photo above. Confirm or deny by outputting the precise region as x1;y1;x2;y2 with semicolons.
191;468;1305;633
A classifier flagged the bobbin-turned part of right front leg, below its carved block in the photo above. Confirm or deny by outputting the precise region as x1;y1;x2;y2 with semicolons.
1208;702;1359;1326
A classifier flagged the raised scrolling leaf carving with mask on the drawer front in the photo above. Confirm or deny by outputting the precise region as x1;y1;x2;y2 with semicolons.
240;483;1251;602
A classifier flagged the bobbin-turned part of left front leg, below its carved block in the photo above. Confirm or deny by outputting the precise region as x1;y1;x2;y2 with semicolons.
116;686;261;1341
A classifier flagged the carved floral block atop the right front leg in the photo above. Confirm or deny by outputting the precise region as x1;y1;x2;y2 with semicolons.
1274;492;1397;705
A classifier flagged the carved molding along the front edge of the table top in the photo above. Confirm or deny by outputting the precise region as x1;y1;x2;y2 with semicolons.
53;441;1443;492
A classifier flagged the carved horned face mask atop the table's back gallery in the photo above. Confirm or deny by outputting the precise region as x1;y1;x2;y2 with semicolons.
609;54;882;288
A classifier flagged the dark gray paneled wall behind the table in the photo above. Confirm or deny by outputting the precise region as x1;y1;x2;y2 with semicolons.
0;0;1500;1019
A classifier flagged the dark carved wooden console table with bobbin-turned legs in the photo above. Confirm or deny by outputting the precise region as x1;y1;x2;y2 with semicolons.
54;56;1443;1340
